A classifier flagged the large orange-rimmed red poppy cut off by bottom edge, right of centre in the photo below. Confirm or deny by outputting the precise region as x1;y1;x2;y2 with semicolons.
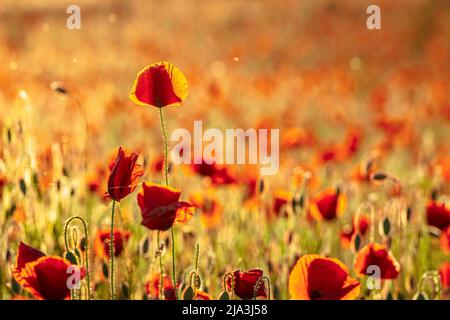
289;254;360;300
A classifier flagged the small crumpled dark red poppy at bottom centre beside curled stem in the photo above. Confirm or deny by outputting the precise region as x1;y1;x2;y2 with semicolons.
227;269;266;300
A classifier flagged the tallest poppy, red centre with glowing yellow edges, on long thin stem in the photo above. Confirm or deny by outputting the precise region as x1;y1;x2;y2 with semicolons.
130;61;188;108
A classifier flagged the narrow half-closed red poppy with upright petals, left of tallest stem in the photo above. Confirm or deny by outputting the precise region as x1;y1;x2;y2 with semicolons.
108;147;144;201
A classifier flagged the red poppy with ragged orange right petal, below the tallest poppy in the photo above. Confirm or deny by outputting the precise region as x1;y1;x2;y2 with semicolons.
137;183;195;231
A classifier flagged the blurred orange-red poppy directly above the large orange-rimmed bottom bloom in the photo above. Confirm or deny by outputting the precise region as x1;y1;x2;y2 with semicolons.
309;189;347;221
